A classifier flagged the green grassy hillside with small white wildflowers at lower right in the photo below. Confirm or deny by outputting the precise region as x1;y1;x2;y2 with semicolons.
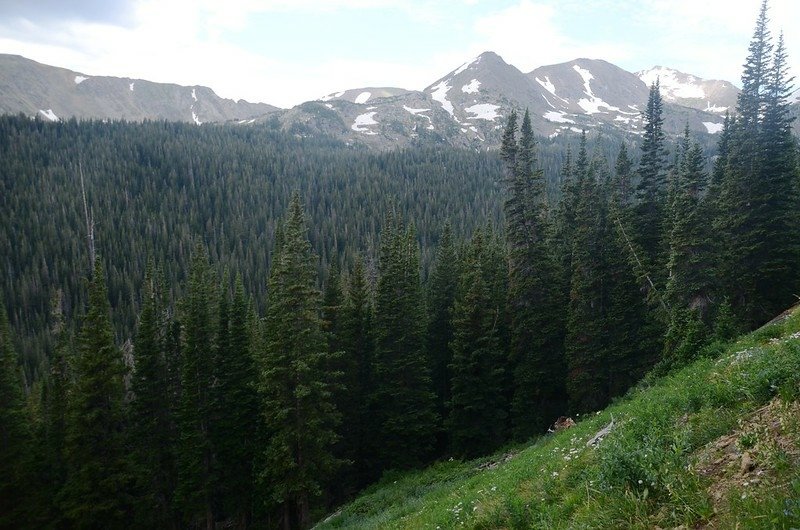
319;309;800;529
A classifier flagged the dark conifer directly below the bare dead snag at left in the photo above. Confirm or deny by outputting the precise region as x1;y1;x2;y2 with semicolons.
60;258;131;528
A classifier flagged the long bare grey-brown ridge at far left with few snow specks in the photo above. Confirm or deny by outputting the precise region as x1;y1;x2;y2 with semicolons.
0;54;277;123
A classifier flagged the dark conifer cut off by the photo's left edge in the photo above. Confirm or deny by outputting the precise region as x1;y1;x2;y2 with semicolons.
0;301;32;528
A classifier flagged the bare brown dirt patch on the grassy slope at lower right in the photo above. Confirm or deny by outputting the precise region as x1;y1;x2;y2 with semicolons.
693;398;800;528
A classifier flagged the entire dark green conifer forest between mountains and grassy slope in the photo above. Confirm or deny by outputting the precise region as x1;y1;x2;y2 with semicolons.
0;3;800;529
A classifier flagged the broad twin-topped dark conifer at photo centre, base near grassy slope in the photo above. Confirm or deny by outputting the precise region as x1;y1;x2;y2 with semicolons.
372;212;439;469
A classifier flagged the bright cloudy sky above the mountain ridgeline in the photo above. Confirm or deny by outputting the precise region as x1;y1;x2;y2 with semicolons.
0;0;800;107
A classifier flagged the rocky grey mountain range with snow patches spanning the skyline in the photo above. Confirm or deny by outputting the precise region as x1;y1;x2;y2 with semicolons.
0;52;800;149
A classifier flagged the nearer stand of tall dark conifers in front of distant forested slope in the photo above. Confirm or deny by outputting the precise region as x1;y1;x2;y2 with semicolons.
0;3;800;528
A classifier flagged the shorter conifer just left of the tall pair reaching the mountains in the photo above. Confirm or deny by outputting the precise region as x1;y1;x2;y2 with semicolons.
446;231;507;457
